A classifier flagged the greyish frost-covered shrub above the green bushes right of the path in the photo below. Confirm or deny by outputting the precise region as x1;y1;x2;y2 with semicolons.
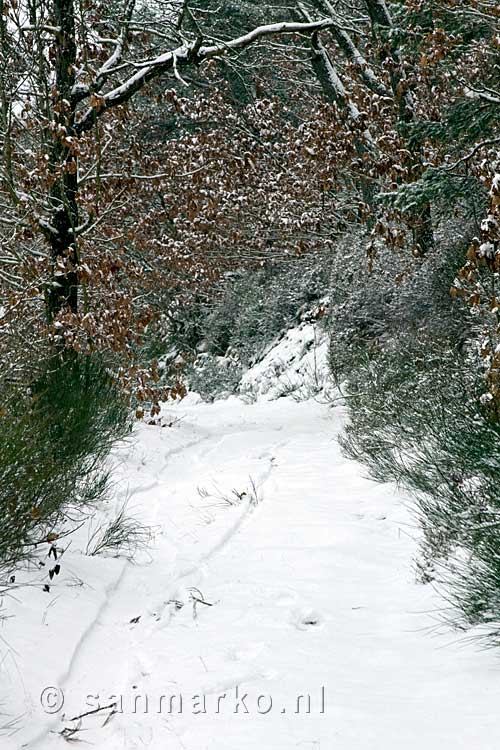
327;232;470;383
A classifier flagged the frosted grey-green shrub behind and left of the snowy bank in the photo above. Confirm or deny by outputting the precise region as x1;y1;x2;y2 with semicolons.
165;252;333;400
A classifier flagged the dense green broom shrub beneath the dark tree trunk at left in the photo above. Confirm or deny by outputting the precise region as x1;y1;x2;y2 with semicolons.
0;356;129;567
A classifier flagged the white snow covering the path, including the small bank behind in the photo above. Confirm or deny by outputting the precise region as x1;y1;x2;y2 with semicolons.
0;324;500;750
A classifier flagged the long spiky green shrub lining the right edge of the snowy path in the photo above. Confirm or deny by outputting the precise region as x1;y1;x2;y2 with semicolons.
331;238;500;641
